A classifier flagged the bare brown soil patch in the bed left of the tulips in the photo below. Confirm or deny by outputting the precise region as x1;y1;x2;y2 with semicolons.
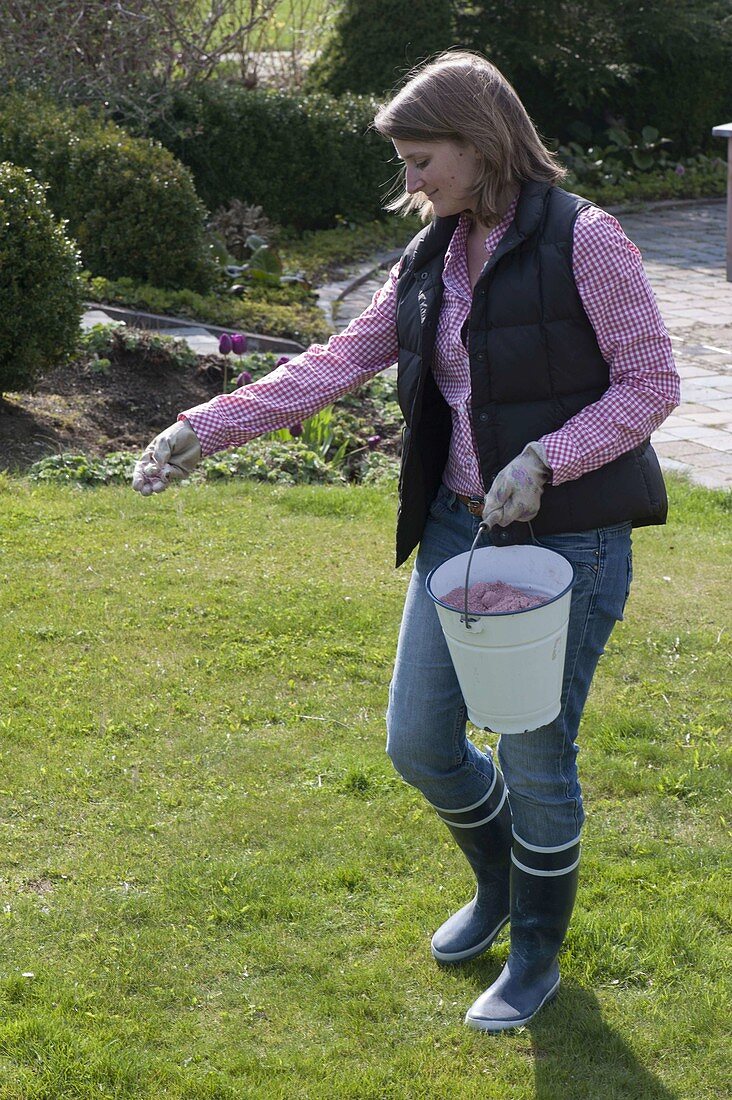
0;356;221;473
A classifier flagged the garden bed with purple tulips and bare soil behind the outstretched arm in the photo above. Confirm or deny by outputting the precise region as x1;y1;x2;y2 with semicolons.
0;326;401;482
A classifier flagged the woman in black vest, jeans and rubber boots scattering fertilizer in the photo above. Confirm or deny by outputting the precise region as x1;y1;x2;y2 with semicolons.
133;52;679;1032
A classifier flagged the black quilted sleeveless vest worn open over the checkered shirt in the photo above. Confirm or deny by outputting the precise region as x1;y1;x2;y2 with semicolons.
396;182;667;565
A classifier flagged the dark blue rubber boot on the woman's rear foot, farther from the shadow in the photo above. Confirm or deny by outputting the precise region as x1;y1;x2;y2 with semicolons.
431;769;511;965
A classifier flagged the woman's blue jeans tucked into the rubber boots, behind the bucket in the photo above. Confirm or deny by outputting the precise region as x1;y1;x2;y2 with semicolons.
386;486;632;848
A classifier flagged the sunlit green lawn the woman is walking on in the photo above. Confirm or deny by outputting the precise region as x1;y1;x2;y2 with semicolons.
0;477;732;1100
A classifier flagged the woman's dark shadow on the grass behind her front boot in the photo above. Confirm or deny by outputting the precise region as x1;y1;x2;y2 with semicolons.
527;982;678;1100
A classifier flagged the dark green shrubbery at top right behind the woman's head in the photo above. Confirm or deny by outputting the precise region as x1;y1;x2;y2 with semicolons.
456;0;732;155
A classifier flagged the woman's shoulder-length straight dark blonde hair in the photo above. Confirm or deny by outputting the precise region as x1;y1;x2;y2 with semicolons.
373;50;566;226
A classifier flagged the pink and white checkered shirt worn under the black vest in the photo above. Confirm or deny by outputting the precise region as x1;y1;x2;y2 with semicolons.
181;202;680;495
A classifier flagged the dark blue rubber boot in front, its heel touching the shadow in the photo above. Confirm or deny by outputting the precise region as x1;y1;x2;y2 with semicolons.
466;834;579;1032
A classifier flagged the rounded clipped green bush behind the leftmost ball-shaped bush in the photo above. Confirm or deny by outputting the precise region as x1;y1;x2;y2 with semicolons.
0;94;215;290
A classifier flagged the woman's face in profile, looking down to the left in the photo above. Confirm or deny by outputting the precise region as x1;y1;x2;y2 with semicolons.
393;141;479;218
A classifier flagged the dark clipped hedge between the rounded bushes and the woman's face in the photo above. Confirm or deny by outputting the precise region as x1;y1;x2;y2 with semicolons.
147;83;395;231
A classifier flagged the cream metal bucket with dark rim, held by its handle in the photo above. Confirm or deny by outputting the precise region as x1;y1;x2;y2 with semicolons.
426;539;575;734
